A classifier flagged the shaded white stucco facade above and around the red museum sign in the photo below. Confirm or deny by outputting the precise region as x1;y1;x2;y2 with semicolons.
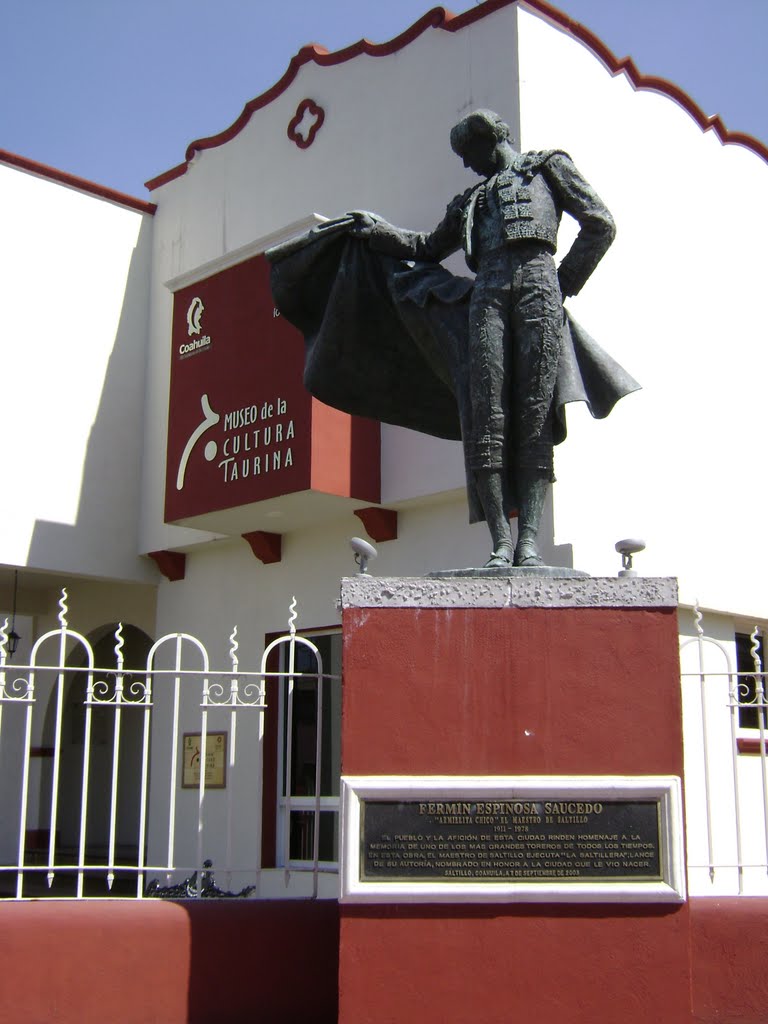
141;9;517;551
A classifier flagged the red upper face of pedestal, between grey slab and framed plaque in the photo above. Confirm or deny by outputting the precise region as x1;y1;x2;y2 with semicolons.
342;608;683;775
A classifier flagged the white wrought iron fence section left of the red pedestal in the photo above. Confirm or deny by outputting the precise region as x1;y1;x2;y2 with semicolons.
0;590;340;898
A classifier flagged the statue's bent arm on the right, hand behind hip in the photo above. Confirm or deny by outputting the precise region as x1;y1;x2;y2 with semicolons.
542;152;616;298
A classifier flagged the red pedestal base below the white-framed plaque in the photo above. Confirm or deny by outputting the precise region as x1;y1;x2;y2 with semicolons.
339;904;690;1024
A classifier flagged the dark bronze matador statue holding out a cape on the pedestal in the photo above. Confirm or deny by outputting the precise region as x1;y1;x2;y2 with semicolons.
266;110;639;570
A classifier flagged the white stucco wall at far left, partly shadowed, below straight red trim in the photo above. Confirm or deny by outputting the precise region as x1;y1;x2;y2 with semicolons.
0;164;157;581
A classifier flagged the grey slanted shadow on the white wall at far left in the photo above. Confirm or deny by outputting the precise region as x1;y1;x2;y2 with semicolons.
28;216;159;583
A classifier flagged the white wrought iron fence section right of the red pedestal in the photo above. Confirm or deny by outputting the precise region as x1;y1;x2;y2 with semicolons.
680;608;768;895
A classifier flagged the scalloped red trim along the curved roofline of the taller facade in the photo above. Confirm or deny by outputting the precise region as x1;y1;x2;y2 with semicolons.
145;0;768;190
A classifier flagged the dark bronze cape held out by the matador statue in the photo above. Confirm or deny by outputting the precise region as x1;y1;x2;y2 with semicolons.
265;217;640;522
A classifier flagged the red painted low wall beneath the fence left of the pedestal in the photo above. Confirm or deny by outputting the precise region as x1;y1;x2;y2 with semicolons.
0;900;339;1024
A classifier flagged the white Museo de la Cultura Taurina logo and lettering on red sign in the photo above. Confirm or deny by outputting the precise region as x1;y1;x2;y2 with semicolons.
176;394;296;490
